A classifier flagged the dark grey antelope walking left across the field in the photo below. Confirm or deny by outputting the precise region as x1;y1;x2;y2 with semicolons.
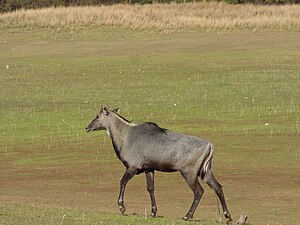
86;107;232;223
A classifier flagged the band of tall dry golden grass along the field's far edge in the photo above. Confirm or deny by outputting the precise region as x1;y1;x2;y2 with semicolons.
0;2;300;30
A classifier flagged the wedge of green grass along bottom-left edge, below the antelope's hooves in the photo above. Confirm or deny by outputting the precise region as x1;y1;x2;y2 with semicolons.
0;205;232;225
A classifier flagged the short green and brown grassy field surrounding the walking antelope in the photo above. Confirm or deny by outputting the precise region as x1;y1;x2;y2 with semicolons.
0;2;300;224
